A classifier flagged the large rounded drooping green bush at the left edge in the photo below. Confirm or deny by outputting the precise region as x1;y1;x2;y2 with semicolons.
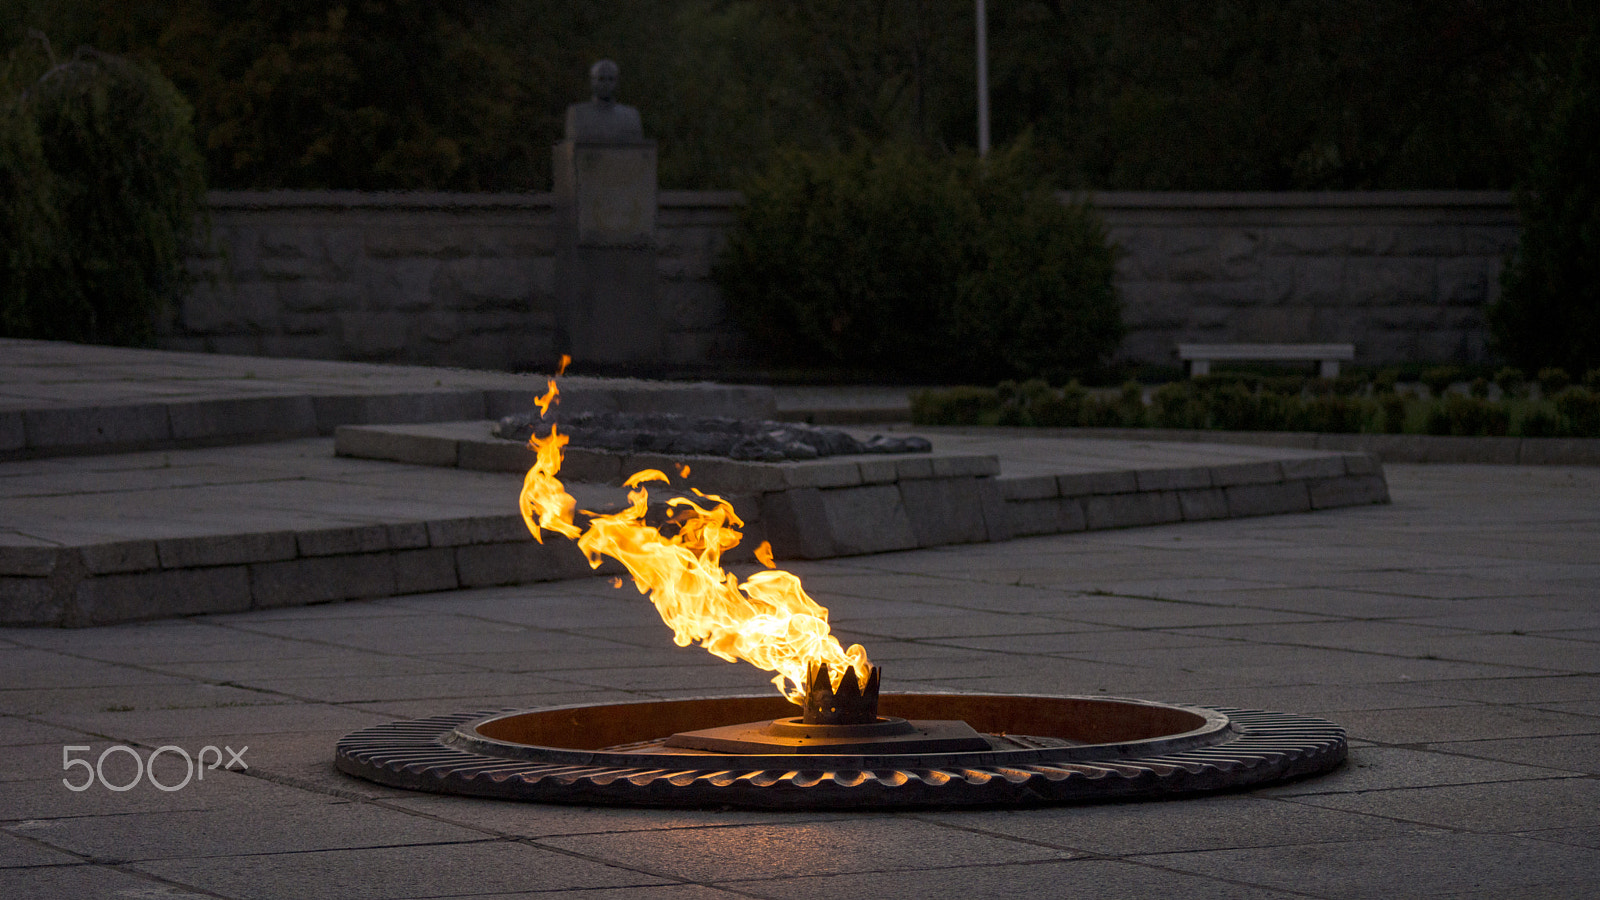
0;38;205;344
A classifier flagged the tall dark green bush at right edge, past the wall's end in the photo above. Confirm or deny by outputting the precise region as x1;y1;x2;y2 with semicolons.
1486;34;1600;372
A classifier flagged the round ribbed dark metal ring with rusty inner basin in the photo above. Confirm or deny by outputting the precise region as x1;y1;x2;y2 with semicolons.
334;693;1347;809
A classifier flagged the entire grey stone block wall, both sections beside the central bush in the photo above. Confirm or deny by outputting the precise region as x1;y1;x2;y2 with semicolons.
162;191;1517;370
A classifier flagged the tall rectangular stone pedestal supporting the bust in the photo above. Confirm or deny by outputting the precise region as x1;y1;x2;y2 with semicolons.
554;141;664;367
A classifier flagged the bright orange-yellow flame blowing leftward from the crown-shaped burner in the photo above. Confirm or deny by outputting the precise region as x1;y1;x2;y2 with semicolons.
520;371;870;705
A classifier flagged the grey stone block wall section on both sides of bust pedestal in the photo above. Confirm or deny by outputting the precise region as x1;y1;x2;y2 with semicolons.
172;191;739;370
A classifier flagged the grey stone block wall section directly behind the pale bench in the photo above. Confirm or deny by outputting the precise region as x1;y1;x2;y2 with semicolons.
1094;191;1517;364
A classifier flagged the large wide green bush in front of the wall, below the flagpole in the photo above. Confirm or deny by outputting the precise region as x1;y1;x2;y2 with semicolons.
714;144;1123;383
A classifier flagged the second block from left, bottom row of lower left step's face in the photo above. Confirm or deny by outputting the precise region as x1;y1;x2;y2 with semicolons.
62;564;249;626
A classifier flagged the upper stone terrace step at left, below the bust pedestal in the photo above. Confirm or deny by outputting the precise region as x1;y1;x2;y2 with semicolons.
0;338;776;461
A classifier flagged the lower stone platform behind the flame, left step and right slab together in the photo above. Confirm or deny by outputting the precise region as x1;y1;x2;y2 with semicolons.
0;421;1387;626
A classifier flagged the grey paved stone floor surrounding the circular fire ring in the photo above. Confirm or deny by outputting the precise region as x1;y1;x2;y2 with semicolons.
0;466;1600;900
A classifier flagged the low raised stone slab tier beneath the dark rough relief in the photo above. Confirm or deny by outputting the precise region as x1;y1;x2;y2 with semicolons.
334;421;1389;559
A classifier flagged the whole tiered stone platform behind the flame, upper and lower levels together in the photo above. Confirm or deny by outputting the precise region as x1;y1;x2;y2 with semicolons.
0;340;1387;626
